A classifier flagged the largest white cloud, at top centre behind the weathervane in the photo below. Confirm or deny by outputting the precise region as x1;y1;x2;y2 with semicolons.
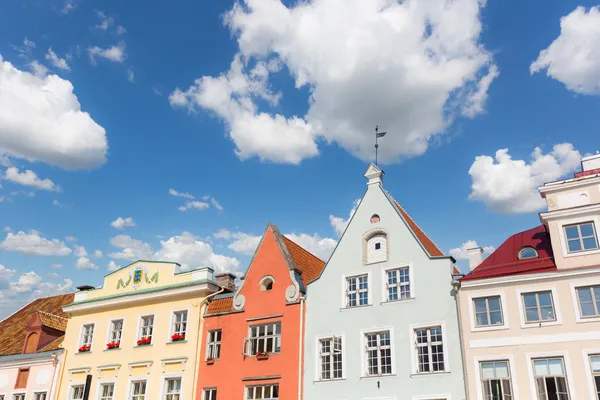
169;0;498;164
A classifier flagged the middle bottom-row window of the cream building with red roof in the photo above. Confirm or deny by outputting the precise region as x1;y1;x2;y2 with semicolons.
533;357;570;400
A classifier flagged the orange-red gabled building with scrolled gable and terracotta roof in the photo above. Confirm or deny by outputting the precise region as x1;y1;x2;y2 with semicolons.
197;224;325;400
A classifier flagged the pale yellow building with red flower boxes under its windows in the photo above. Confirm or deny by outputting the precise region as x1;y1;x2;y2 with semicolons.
57;261;220;400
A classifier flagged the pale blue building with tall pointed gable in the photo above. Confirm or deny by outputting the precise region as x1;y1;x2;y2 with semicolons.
303;164;465;400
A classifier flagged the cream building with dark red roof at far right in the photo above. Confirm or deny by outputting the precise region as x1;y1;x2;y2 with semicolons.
455;155;600;400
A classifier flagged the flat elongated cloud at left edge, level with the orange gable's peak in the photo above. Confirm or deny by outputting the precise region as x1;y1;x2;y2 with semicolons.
0;230;72;256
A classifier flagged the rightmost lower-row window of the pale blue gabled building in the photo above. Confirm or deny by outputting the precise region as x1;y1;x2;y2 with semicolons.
415;326;445;373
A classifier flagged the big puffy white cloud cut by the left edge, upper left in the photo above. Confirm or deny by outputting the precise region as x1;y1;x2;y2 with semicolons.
0;57;108;169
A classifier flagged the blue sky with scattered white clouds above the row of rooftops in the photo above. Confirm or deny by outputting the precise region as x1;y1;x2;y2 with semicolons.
0;0;600;317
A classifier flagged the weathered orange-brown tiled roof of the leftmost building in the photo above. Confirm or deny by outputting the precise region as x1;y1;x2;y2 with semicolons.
0;293;74;355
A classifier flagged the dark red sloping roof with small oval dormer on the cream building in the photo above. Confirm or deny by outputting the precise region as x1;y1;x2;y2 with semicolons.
461;225;556;281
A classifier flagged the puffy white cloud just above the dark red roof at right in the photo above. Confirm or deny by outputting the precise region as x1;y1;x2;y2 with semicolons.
469;143;581;213
